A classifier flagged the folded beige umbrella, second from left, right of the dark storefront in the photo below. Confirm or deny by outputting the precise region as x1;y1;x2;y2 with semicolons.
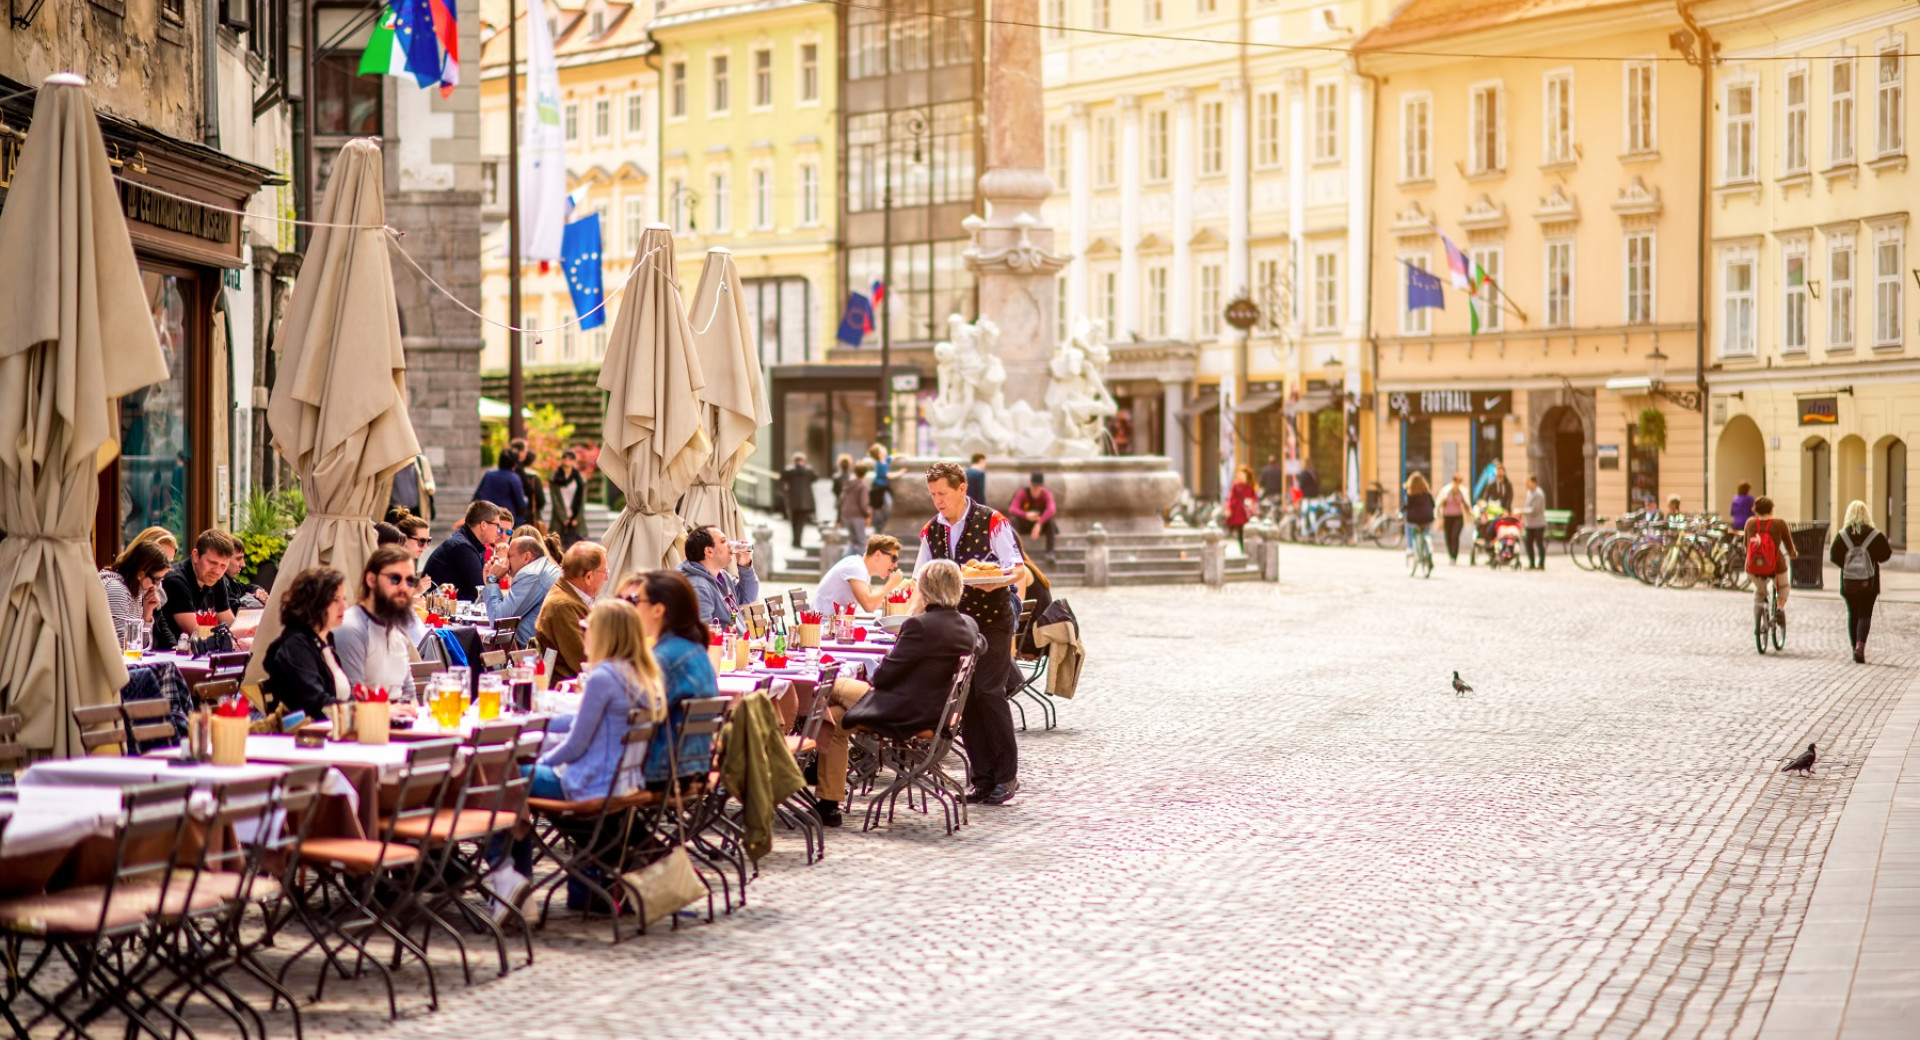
248;140;420;675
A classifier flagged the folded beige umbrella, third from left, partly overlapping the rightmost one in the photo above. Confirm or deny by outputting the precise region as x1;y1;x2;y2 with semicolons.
599;225;712;579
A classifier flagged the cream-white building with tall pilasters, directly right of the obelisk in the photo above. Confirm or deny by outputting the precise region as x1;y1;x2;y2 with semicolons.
1043;0;1388;497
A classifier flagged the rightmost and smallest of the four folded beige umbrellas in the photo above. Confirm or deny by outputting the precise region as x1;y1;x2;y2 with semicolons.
680;246;774;537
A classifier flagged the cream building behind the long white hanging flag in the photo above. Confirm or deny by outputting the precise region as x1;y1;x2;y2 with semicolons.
480;0;660;372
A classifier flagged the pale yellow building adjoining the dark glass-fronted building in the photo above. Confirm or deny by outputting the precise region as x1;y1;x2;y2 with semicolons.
651;0;841;368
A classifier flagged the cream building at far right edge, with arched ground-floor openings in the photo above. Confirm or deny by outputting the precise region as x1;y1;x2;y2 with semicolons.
1695;0;1920;549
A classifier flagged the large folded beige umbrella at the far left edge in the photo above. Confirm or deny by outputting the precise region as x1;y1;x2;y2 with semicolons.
0;75;167;756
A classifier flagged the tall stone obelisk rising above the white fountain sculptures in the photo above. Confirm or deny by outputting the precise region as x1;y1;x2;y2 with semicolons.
966;0;1068;411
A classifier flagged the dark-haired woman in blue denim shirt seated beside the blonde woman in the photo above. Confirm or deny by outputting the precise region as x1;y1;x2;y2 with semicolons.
620;570;720;791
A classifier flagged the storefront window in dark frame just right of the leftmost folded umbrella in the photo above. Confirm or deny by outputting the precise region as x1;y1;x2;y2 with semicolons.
119;271;196;545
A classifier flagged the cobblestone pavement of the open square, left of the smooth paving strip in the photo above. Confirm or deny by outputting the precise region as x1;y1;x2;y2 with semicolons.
274;547;1920;1040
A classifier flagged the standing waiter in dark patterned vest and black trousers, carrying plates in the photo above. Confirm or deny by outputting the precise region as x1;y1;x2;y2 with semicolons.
914;462;1021;806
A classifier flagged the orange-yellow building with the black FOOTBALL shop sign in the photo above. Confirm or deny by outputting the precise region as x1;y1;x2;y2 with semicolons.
1356;0;1724;522
